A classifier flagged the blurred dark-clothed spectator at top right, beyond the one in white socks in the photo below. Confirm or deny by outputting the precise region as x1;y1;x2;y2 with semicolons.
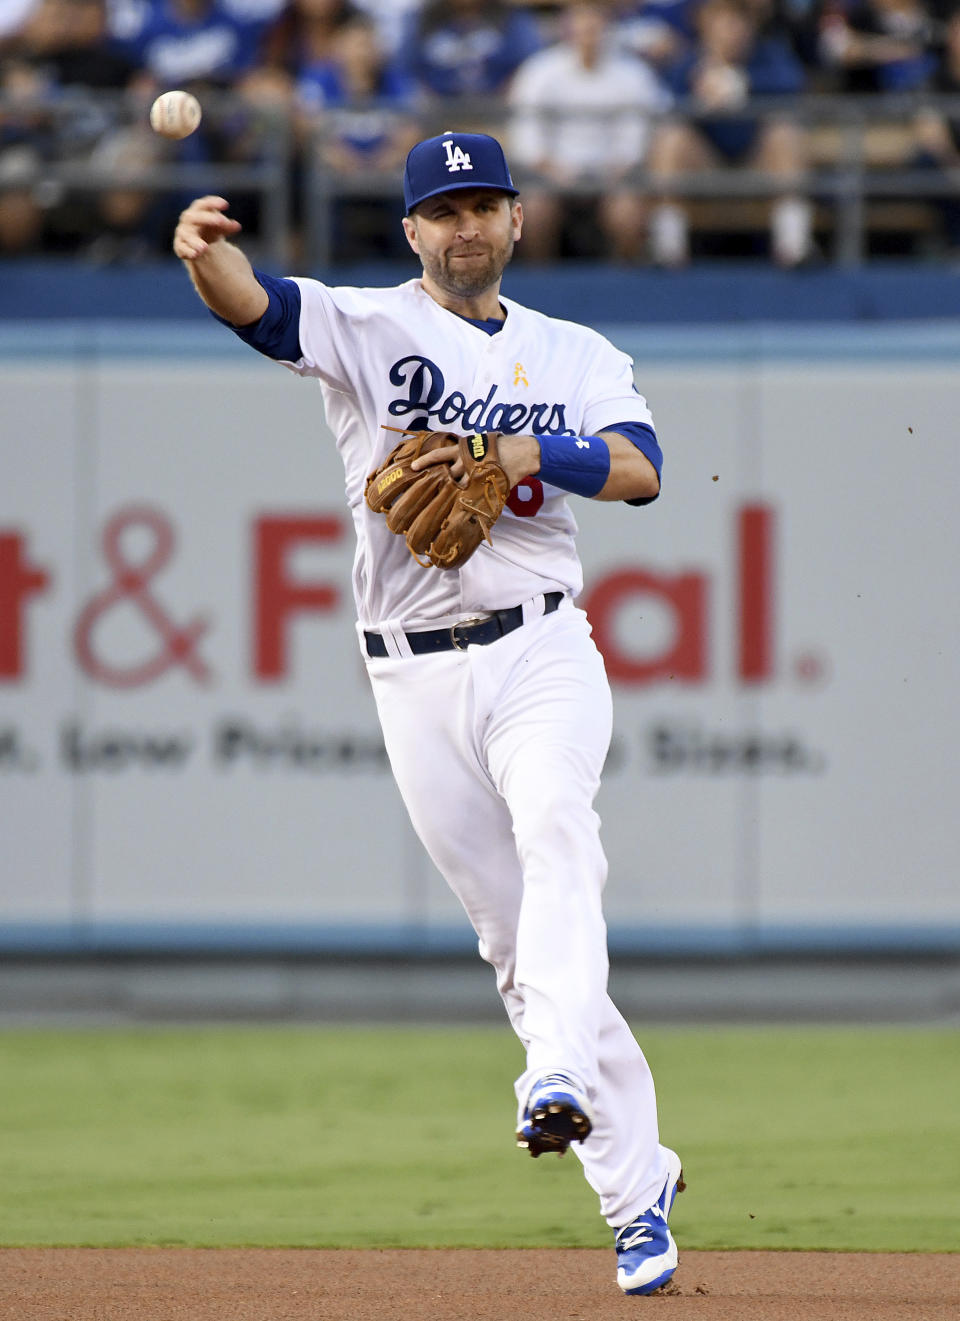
820;0;936;94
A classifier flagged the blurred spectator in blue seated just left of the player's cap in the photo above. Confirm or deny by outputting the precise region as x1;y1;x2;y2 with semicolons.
296;12;420;260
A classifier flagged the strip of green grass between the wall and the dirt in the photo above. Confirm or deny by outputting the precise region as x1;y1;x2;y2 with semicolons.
0;1028;960;1251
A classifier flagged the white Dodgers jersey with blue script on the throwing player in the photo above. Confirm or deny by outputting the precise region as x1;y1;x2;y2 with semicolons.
277;279;652;630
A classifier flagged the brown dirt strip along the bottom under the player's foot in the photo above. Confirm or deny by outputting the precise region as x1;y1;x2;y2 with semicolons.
0;1248;960;1321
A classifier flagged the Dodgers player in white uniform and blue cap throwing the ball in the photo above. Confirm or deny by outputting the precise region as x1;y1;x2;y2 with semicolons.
173;132;684;1293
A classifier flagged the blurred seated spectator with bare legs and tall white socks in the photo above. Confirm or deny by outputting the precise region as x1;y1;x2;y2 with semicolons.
650;0;812;267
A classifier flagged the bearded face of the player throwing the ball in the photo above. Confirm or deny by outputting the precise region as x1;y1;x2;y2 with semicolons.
403;188;523;299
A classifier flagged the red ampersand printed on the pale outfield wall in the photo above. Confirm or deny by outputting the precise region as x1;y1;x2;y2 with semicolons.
74;506;210;688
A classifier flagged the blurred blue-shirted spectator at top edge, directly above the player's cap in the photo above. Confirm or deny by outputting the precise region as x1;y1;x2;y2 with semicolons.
399;0;543;99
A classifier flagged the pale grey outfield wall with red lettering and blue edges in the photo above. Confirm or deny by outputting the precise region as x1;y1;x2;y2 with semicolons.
0;321;960;951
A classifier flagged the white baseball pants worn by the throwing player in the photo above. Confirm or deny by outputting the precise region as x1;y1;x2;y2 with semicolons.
367;600;667;1226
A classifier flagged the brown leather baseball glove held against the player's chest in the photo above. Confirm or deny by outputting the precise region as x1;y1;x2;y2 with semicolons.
364;431;510;569
